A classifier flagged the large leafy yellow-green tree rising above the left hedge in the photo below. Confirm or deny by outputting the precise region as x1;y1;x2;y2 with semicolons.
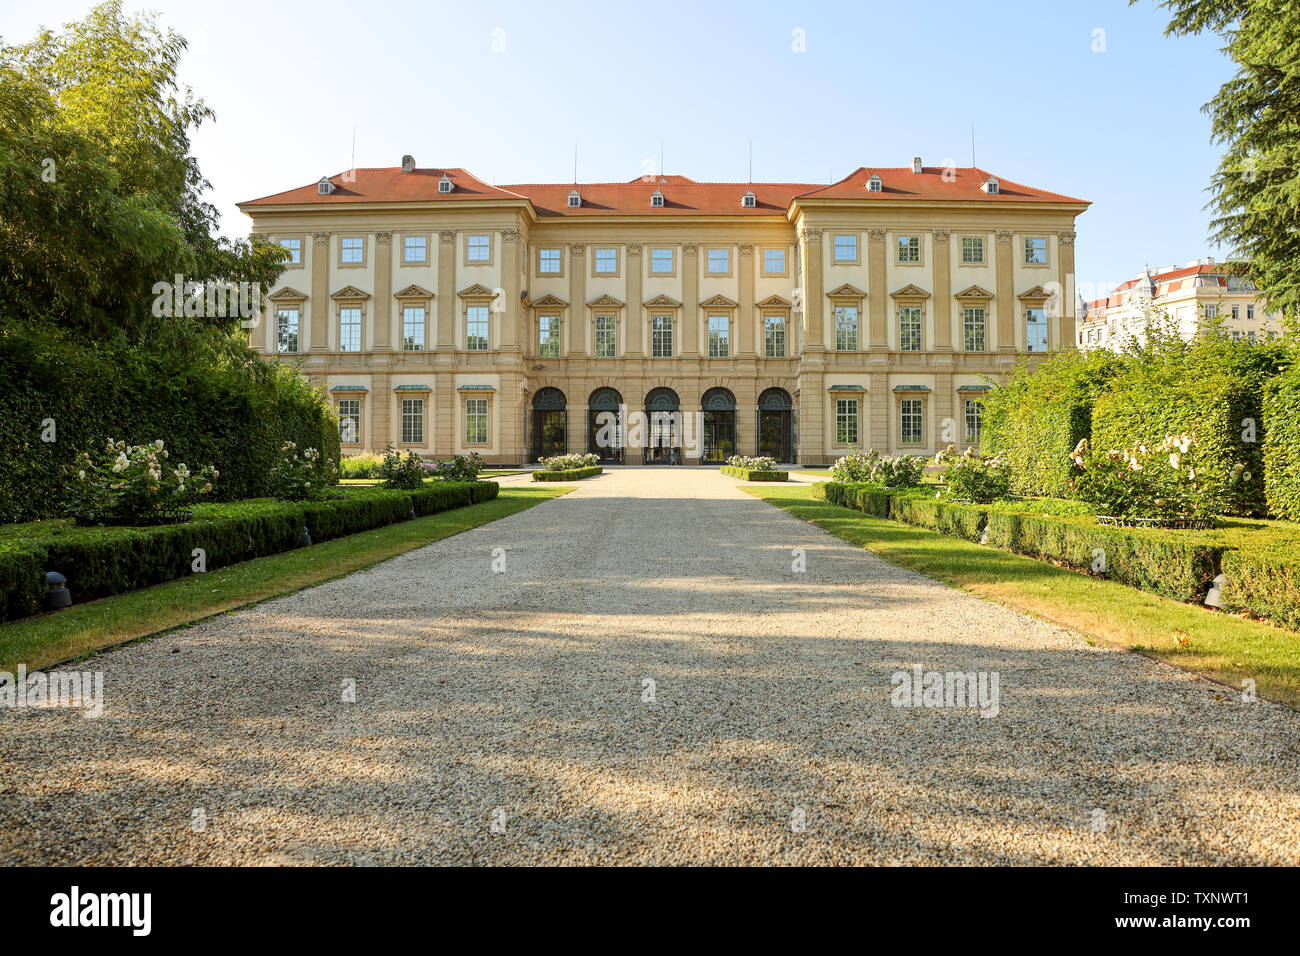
0;0;286;339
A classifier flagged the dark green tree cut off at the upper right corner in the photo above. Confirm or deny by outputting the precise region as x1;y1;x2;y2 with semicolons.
1149;0;1300;329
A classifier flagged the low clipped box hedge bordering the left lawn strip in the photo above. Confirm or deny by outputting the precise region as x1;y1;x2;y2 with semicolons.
0;481;501;619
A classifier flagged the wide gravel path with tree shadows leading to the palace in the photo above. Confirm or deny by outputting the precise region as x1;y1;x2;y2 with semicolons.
0;468;1300;864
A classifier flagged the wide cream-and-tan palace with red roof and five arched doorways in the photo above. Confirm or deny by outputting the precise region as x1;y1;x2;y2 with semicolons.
239;157;1088;464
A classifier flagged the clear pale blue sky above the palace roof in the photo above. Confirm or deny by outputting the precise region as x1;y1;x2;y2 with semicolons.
0;0;1232;294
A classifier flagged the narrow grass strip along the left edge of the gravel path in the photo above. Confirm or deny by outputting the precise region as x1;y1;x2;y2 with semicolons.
0;485;573;671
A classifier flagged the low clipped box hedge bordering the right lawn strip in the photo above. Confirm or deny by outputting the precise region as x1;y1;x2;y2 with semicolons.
813;483;1300;628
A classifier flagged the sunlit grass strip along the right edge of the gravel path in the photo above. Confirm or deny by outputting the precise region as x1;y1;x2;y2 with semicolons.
744;485;1300;706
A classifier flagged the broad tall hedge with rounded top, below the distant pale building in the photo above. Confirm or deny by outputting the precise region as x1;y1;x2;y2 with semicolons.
1092;336;1284;516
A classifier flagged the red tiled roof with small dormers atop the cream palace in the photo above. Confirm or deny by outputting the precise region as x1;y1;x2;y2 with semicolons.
239;166;1087;217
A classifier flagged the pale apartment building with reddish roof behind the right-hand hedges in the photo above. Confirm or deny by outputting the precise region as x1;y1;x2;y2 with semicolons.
1075;258;1282;351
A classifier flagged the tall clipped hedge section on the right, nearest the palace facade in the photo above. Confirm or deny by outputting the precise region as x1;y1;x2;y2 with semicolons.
980;350;1121;498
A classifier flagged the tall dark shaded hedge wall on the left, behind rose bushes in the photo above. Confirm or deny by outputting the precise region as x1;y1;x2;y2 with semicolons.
0;324;339;523
